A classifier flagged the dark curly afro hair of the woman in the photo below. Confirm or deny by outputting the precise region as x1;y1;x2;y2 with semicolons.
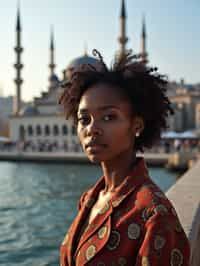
59;50;173;151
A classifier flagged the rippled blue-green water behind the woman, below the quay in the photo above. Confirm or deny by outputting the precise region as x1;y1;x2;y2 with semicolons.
0;162;176;266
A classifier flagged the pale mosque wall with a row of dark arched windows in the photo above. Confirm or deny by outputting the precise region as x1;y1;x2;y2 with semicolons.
10;115;81;151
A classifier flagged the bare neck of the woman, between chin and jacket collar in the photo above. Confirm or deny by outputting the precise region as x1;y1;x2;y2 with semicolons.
101;153;136;193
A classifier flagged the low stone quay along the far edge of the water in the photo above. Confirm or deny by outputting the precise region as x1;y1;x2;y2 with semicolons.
0;150;199;171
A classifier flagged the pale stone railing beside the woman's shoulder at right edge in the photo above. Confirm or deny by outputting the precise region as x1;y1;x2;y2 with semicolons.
166;161;200;266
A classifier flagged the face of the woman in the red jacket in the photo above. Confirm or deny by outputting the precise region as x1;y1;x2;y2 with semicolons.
77;83;141;163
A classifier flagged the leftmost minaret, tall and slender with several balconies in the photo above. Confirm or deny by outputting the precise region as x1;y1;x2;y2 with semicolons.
13;6;23;114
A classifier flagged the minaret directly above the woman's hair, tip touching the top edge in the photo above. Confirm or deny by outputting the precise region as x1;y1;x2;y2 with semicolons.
118;0;128;57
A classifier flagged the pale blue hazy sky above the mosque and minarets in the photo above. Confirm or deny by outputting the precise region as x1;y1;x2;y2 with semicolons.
0;0;200;101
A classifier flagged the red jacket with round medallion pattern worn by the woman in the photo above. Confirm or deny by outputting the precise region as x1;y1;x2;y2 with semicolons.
60;159;190;266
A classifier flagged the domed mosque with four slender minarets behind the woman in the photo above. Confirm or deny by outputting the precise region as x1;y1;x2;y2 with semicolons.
10;0;147;152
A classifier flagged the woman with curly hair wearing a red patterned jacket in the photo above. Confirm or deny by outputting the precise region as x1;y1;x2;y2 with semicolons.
60;50;189;266
